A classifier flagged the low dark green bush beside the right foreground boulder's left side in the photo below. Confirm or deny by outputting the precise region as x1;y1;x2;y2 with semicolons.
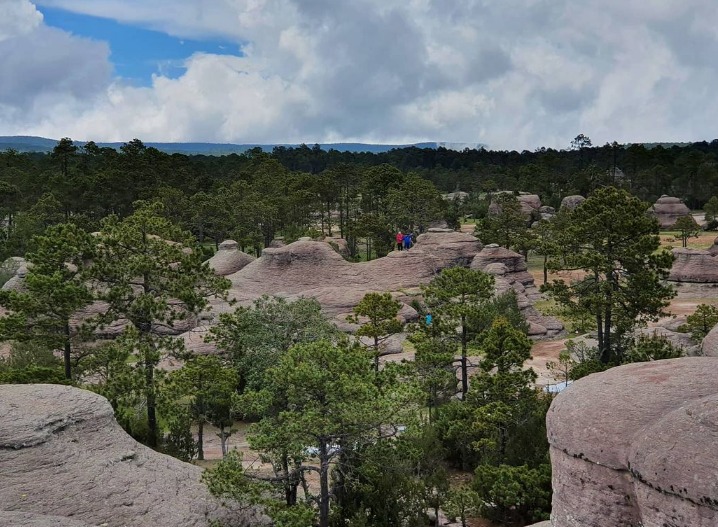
472;464;551;525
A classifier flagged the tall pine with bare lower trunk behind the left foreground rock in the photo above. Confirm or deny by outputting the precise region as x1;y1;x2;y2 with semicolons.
86;202;229;446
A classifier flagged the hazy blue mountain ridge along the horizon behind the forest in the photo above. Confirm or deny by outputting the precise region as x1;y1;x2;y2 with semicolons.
0;135;484;156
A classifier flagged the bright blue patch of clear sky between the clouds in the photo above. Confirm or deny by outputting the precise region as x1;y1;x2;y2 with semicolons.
38;7;241;86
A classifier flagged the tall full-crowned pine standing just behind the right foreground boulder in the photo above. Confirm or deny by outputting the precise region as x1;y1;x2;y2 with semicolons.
542;187;675;364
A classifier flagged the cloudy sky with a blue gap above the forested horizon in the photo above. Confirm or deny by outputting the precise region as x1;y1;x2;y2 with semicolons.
0;0;718;150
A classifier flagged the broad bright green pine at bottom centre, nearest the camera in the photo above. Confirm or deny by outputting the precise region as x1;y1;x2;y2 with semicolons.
231;341;416;527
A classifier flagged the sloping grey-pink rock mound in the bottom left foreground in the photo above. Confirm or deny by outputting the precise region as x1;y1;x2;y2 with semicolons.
0;384;262;527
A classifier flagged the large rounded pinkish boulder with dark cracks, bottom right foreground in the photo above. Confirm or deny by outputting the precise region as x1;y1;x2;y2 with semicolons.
547;357;718;527
